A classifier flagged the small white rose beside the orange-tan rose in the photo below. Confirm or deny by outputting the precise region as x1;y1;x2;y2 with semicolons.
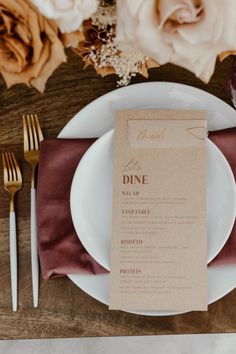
32;0;97;33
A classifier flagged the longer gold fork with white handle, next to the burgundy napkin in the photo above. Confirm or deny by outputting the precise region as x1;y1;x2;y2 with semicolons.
23;114;43;307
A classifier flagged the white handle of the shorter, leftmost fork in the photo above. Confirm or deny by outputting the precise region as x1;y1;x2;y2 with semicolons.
9;211;17;311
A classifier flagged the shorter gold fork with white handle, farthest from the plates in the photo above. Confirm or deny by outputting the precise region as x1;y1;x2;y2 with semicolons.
2;152;22;311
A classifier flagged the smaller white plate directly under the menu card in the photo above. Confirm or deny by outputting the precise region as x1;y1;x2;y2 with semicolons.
70;130;236;270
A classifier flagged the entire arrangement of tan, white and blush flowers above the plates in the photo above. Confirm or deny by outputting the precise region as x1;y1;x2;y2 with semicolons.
0;0;236;92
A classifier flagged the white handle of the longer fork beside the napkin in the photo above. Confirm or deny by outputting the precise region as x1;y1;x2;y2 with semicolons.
31;188;39;307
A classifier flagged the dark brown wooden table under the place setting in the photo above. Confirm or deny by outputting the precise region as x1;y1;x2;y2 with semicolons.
0;52;236;339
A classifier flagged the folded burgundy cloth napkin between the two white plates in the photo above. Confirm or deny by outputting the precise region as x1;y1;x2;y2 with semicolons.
37;128;236;279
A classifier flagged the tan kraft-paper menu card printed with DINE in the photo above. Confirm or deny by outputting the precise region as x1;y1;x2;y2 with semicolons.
109;110;208;311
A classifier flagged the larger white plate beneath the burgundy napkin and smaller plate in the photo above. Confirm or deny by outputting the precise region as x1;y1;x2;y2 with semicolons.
58;82;236;316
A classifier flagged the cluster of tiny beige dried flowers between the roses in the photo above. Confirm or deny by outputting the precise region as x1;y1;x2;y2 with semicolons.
76;12;159;86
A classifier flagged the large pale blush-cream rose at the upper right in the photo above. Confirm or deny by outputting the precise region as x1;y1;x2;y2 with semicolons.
117;0;236;82
